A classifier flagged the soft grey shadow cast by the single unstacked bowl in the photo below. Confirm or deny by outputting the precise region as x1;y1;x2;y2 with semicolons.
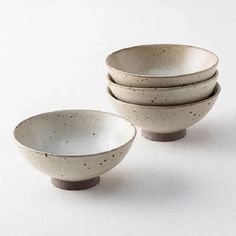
85;168;198;206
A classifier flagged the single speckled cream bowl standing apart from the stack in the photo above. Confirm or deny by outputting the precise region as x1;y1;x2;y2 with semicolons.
14;110;136;190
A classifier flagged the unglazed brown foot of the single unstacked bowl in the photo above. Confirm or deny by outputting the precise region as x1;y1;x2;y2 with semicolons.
51;177;100;190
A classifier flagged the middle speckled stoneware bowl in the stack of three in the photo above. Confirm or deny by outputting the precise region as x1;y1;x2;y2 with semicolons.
107;72;218;105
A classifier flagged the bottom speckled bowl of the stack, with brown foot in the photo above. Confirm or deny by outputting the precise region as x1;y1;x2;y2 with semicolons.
108;83;220;141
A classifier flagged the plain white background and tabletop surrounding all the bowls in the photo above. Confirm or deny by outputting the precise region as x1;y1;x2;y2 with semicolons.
0;0;236;236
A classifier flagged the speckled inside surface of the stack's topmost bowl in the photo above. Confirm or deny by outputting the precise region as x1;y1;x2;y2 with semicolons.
107;44;218;77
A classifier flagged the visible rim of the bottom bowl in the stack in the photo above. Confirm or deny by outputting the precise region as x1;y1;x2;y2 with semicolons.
107;82;221;109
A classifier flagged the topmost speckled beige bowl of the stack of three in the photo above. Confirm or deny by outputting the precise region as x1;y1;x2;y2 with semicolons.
106;44;218;88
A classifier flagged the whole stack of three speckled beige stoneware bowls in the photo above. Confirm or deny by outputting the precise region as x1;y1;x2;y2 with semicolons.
106;44;220;141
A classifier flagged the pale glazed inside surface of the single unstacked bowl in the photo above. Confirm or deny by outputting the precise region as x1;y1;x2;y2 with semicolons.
14;110;136;156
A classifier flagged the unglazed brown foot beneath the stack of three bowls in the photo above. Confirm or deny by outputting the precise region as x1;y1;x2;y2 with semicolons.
141;129;186;142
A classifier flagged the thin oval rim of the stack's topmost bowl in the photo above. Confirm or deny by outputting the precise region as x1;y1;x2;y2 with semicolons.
106;43;219;79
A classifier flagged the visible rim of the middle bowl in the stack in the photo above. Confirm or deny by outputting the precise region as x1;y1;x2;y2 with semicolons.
106;70;219;91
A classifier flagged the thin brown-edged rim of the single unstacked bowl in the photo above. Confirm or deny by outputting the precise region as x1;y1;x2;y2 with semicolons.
13;109;137;159
